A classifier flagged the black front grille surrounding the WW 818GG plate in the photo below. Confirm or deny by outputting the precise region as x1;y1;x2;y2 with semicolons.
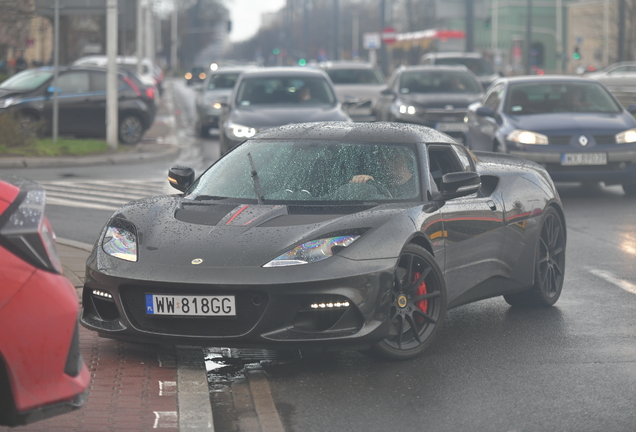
120;286;268;337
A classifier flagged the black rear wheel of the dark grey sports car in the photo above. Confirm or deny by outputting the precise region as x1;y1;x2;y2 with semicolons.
504;207;565;307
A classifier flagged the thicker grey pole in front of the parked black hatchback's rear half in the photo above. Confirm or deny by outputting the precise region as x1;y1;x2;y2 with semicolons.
106;0;118;150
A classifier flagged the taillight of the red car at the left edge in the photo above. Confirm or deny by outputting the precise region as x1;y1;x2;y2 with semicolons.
0;183;62;273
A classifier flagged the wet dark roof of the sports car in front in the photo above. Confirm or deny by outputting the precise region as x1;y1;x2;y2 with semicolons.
254;122;455;144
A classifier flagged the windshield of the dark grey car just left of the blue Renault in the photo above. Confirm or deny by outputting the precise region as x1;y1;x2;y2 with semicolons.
400;70;483;94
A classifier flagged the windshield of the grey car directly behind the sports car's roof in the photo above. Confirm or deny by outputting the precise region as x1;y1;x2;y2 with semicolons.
236;76;336;106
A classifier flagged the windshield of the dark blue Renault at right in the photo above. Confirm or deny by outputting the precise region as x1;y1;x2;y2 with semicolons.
505;82;622;115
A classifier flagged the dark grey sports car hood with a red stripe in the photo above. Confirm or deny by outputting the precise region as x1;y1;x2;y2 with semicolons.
99;196;414;268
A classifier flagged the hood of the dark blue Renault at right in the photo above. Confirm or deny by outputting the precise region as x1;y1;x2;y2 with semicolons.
509;112;636;135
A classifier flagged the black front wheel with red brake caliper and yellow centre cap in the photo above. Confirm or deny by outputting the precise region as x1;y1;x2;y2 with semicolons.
370;244;446;360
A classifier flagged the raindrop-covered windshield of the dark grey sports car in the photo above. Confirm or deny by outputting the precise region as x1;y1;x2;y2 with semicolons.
186;140;420;204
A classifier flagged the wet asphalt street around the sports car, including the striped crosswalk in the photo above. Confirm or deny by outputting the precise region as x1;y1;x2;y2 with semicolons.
4;81;636;432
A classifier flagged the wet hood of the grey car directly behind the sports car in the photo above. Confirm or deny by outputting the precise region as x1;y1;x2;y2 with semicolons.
229;105;350;129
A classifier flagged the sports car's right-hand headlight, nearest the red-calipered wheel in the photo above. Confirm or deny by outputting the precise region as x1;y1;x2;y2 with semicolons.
263;235;360;267
